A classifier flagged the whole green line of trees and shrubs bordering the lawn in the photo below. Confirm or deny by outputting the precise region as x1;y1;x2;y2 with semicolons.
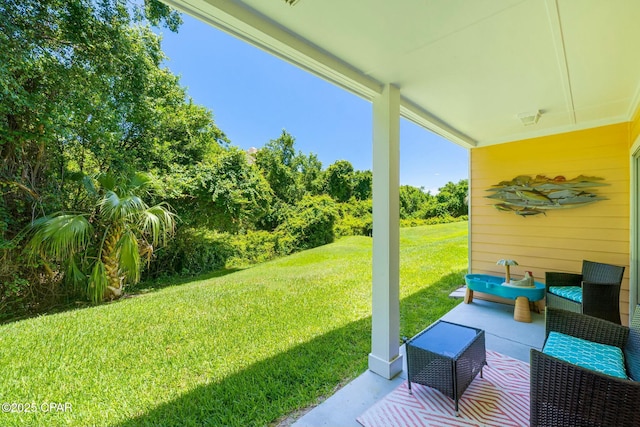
0;0;467;321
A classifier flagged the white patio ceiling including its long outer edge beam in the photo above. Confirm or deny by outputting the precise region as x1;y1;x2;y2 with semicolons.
163;0;640;147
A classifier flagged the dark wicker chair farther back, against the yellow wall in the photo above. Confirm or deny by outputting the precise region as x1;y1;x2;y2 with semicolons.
545;261;624;324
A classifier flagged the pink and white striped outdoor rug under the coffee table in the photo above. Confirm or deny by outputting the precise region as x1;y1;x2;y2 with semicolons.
358;351;529;427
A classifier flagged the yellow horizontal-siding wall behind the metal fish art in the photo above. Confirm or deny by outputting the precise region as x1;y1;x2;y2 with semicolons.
470;123;640;323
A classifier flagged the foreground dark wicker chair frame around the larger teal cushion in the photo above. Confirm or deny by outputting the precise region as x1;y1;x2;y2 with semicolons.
530;306;640;427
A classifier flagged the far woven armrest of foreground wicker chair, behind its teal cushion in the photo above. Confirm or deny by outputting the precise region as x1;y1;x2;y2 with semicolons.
545;307;629;349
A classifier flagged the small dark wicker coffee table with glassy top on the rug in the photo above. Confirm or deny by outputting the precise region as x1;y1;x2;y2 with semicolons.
405;320;487;415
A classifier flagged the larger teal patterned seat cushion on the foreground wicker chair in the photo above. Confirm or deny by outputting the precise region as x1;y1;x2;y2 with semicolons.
542;332;627;379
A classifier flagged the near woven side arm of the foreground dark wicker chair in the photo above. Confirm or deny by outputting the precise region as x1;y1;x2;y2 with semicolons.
529;349;640;426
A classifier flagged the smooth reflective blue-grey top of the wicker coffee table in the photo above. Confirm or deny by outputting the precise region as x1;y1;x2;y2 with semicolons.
409;320;480;358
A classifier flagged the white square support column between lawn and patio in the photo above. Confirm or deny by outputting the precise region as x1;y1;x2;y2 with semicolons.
369;85;402;379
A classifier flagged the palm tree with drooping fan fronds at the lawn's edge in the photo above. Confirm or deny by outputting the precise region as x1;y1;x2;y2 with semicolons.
27;174;175;303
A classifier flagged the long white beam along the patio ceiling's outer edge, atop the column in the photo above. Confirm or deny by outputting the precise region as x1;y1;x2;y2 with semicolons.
162;0;476;148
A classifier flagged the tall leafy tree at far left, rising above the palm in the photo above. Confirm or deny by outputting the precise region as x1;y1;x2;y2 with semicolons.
0;0;184;239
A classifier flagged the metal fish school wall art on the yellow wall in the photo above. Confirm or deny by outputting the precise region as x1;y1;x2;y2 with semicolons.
486;175;609;218
